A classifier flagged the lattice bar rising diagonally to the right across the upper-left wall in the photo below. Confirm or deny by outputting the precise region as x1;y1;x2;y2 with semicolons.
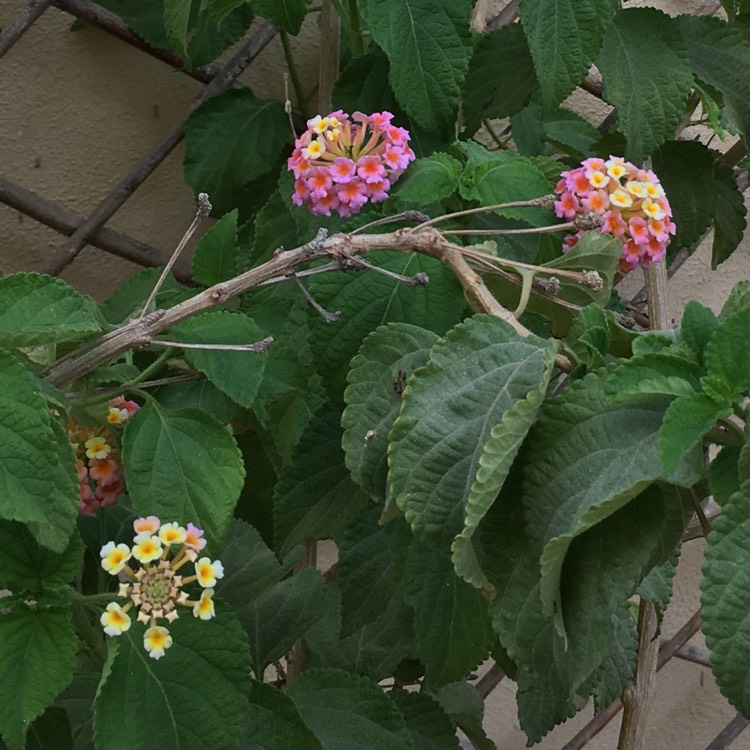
43;23;277;276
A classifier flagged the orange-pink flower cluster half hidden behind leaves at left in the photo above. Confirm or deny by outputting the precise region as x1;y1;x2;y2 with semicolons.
68;396;139;516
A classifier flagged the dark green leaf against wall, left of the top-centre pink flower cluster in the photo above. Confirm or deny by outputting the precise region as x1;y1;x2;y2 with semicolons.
185;88;288;215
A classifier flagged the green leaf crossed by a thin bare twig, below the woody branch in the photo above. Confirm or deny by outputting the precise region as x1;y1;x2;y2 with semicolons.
173;310;266;407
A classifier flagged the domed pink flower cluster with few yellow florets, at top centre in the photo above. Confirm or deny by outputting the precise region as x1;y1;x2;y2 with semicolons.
287;110;414;216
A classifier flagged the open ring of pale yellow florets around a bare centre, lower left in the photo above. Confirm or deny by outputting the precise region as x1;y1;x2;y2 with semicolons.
100;516;224;659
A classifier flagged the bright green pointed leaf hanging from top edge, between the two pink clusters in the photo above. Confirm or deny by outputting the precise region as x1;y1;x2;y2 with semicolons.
518;0;618;107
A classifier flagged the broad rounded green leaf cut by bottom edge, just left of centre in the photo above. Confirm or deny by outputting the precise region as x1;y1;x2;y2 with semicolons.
287;669;414;750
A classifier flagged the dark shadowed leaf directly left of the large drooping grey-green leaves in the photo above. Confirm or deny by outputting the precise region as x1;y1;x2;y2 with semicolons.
273;412;368;553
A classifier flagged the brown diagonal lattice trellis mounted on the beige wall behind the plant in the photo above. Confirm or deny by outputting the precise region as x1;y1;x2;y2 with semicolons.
0;0;750;750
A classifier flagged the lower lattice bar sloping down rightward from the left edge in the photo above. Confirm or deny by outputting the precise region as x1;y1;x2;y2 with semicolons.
0;176;191;283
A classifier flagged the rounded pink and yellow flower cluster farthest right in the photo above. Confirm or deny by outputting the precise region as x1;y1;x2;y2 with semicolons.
555;156;675;273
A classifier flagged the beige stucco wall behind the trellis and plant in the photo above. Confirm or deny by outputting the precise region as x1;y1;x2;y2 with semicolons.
0;0;750;750
